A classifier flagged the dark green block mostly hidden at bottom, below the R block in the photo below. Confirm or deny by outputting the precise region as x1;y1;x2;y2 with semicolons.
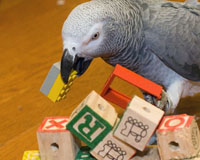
75;146;96;160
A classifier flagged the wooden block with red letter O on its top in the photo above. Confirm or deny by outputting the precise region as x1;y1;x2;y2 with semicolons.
157;114;200;160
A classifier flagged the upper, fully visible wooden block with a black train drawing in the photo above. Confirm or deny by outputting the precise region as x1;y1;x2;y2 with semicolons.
114;96;164;151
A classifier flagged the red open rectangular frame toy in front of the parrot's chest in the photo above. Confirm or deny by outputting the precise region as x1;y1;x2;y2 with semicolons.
101;64;162;108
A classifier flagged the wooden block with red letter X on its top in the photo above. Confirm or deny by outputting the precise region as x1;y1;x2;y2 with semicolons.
37;117;78;160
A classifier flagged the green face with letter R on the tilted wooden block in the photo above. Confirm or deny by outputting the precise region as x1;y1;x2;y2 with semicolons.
67;105;112;149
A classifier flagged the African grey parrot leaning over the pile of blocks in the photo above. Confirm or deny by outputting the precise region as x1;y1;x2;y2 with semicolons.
61;0;200;112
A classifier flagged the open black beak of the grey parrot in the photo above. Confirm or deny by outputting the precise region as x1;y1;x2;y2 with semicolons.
61;49;92;83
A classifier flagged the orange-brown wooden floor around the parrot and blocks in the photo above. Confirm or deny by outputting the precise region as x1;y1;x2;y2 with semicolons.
0;0;200;160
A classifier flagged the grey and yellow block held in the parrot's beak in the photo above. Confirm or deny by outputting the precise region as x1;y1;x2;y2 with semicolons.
40;62;77;102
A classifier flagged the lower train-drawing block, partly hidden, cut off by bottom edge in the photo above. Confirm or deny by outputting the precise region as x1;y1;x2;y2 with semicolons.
91;119;136;160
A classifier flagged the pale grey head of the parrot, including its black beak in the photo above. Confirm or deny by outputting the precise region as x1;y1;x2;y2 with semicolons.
61;0;143;83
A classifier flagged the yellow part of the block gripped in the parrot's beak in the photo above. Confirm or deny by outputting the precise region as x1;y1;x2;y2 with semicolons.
48;70;77;102
